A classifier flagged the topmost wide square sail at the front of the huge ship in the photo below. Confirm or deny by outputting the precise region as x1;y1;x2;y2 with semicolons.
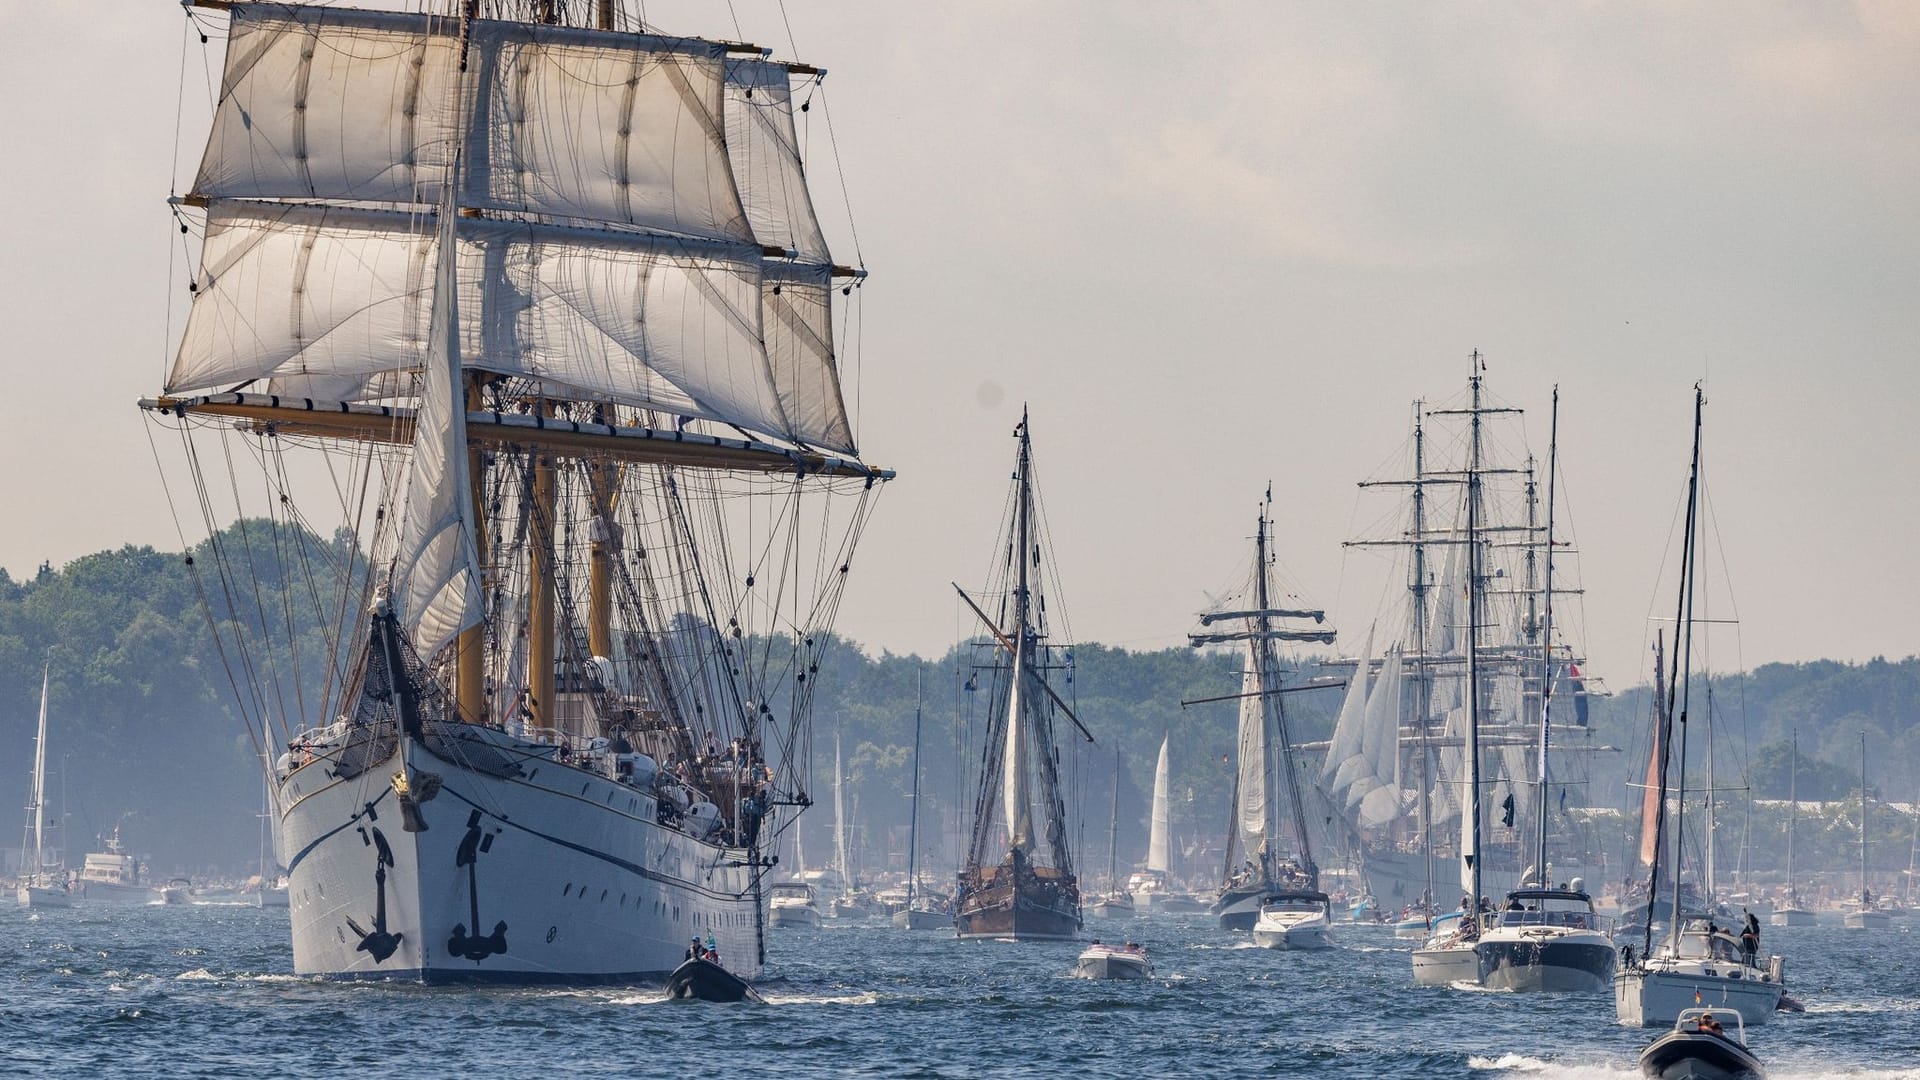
194;4;751;240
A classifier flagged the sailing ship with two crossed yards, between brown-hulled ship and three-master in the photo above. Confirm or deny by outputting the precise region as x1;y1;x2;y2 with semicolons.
1187;484;1334;930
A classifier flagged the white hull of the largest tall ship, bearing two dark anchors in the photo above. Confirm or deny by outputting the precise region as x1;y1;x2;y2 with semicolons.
278;728;758;982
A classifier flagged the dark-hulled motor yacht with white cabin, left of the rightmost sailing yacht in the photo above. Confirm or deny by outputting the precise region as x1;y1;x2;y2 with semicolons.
1478;878;1615;994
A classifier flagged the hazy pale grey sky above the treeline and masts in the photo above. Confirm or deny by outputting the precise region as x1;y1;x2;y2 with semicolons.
0;0;1920;686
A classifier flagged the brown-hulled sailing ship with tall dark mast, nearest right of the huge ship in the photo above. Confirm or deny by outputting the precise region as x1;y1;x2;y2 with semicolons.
954;413;1092;942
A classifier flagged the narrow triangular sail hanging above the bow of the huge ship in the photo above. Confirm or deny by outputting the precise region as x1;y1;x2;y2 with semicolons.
394;191;486;657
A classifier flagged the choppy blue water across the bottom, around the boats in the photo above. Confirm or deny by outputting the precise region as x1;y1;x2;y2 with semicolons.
0;905;1920;1080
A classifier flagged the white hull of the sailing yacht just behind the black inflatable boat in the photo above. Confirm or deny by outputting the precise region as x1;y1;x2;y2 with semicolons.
1613;922;1786;1028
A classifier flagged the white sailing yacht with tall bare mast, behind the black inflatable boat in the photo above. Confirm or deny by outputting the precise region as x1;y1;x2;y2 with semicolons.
1613;386;1786;1026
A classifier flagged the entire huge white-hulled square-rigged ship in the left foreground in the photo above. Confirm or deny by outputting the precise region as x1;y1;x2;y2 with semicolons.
142;0;891;982
